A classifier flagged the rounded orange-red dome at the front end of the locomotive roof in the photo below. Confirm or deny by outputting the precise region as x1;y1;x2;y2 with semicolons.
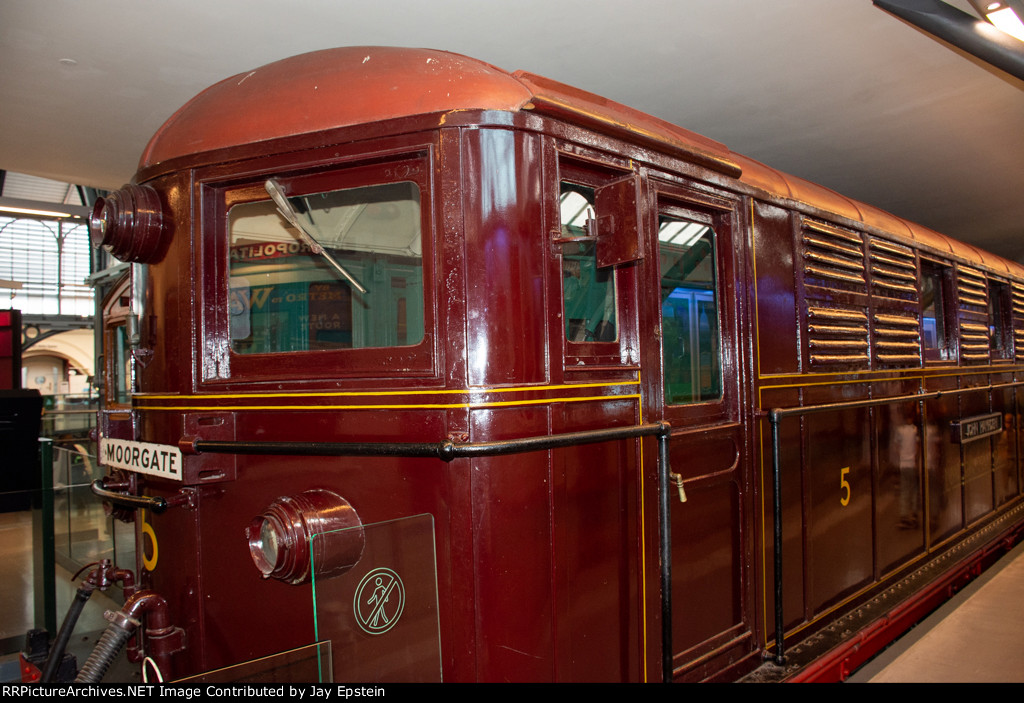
139;46;531;170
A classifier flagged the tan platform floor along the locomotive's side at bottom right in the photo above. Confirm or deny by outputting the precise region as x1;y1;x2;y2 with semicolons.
848;543;1024;684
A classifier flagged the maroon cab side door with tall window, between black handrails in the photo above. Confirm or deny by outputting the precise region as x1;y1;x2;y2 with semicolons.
644;184;754;680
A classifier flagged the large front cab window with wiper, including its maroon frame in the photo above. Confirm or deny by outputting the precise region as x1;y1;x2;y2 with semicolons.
205;153;433;379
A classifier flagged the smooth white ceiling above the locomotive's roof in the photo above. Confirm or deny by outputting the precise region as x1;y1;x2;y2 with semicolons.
0;0;1024;261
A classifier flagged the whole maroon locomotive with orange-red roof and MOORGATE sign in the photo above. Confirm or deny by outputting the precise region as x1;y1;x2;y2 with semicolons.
81;48;1024;682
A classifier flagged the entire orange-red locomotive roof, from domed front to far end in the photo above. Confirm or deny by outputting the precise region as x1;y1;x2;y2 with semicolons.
139;47;1024;277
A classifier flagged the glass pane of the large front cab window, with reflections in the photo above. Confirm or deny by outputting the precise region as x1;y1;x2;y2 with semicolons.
228;182;424;354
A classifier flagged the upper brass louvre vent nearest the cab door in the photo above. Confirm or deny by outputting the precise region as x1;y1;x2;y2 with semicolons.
803;221;867;293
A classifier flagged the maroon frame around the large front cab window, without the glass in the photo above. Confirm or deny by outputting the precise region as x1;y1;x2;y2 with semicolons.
195;145;439;385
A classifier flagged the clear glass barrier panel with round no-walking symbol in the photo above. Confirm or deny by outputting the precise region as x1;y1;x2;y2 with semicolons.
309;515;441;683
